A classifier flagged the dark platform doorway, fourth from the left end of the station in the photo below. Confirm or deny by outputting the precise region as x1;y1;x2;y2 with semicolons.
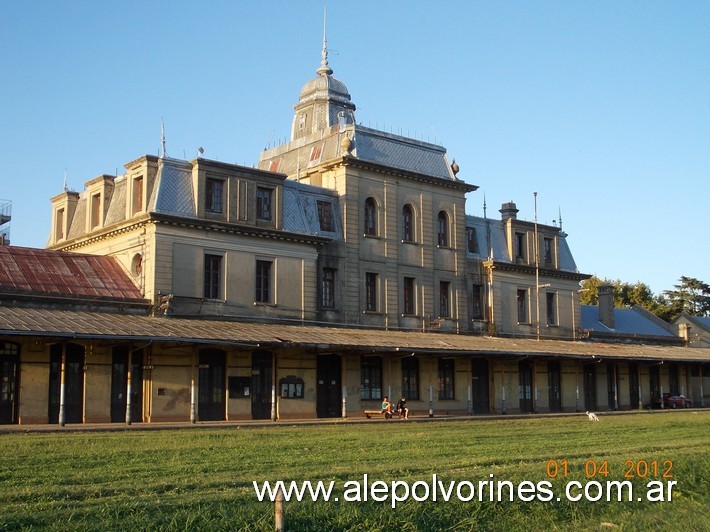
197;349;226;421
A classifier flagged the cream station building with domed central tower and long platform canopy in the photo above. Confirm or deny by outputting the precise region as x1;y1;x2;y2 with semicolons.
0;43;710;423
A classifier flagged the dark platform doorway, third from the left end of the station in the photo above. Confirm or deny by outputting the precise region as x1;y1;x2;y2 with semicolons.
111;346;143;423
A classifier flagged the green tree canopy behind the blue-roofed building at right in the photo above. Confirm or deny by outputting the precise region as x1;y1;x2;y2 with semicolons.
579;276;710;322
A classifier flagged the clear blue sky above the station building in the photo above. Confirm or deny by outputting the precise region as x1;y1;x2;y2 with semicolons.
0;0;710;293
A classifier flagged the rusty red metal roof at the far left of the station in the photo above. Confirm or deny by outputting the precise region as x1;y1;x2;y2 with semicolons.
0;246;143;300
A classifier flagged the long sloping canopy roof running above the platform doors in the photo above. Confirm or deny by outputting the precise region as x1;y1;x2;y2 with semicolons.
0;307;710;362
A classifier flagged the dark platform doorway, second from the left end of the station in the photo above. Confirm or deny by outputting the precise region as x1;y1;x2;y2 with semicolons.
48;344;84;423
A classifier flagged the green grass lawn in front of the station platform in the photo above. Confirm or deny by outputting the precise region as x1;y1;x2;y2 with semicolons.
0;412;710;530
